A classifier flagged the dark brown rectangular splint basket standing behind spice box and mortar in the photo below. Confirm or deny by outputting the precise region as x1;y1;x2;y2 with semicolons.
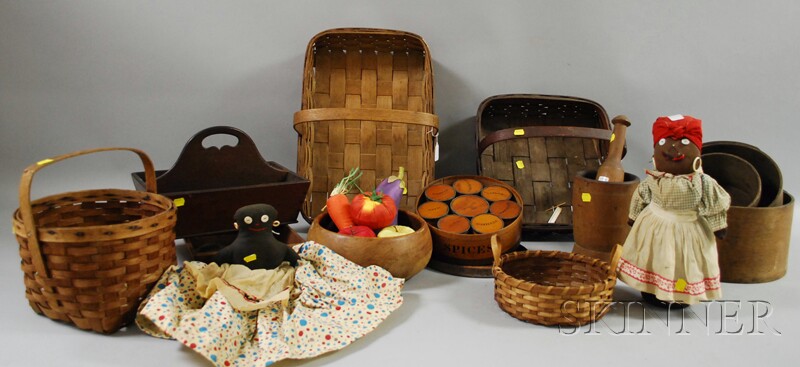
476;94;611;232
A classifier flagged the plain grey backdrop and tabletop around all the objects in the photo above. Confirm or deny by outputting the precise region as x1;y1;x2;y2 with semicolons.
0;0;800;366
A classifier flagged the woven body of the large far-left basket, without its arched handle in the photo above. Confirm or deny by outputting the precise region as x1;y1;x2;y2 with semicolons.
14;190;176;333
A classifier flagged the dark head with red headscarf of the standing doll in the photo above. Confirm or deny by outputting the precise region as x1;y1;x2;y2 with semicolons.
653;115;703;175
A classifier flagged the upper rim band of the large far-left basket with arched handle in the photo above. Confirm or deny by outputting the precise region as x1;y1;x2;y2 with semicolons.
13;189;177;243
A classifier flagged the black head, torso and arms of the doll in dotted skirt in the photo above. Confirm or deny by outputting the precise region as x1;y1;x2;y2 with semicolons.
215;204;300;269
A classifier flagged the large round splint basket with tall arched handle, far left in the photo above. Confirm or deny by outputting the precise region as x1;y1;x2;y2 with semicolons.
13;148;176;333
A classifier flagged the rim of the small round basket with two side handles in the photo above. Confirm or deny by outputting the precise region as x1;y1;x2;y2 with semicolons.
492;250;617;295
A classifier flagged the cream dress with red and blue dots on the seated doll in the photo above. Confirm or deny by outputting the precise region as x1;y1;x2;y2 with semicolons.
136;241;404;366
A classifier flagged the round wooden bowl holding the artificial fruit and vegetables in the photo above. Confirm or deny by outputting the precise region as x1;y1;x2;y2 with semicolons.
308;210;432;279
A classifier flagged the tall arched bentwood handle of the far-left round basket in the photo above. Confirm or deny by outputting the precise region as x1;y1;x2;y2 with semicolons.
19;147;156;277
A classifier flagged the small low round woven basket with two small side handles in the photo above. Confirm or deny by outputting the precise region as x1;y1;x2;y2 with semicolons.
492;238;621;326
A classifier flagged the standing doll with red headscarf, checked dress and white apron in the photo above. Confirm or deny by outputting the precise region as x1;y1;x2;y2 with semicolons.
619;115;731;306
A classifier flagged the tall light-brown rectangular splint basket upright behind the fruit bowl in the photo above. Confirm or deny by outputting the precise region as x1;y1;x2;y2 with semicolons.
294;28;438;219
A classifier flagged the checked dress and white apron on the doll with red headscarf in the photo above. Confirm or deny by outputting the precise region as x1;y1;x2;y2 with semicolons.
618;171;730;304
